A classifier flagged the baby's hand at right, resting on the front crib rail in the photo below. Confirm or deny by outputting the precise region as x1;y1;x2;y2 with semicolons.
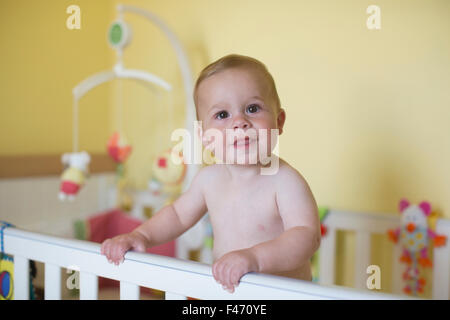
212;249;259;293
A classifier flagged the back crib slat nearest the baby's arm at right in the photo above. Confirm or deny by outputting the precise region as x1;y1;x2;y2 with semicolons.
319;225;336;285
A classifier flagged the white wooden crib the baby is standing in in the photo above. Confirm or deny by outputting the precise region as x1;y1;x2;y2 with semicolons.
4;211;450;300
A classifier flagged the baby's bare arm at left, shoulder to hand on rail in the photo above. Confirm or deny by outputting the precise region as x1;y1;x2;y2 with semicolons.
101;170;207;264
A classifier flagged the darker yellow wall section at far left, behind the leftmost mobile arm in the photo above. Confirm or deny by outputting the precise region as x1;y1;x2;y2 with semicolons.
0;0;113;155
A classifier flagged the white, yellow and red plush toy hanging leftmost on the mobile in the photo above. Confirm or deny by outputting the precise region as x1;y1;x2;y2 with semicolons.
59;151;91;201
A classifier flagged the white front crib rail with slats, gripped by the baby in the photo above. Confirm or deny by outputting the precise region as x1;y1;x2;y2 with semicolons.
4;228;402;300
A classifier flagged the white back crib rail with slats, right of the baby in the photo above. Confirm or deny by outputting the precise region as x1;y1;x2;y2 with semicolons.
319;210;450;300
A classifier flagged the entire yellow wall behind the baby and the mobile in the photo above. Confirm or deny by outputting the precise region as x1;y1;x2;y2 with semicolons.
0;0;450;296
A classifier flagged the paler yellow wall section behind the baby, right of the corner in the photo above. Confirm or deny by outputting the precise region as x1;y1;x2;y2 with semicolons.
104;0;450;217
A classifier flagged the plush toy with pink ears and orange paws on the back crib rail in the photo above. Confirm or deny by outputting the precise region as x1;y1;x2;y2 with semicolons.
388;199;446;295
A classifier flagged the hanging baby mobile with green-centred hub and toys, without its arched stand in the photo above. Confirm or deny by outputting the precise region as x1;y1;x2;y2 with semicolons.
59;6;180;201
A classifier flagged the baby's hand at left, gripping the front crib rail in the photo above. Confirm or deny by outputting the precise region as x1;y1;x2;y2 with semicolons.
100;232;148;265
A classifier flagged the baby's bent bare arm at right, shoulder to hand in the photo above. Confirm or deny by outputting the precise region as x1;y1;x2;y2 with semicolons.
213;168;320;292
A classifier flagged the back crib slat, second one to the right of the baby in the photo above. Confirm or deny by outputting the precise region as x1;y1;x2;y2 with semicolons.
355;230;371;289
